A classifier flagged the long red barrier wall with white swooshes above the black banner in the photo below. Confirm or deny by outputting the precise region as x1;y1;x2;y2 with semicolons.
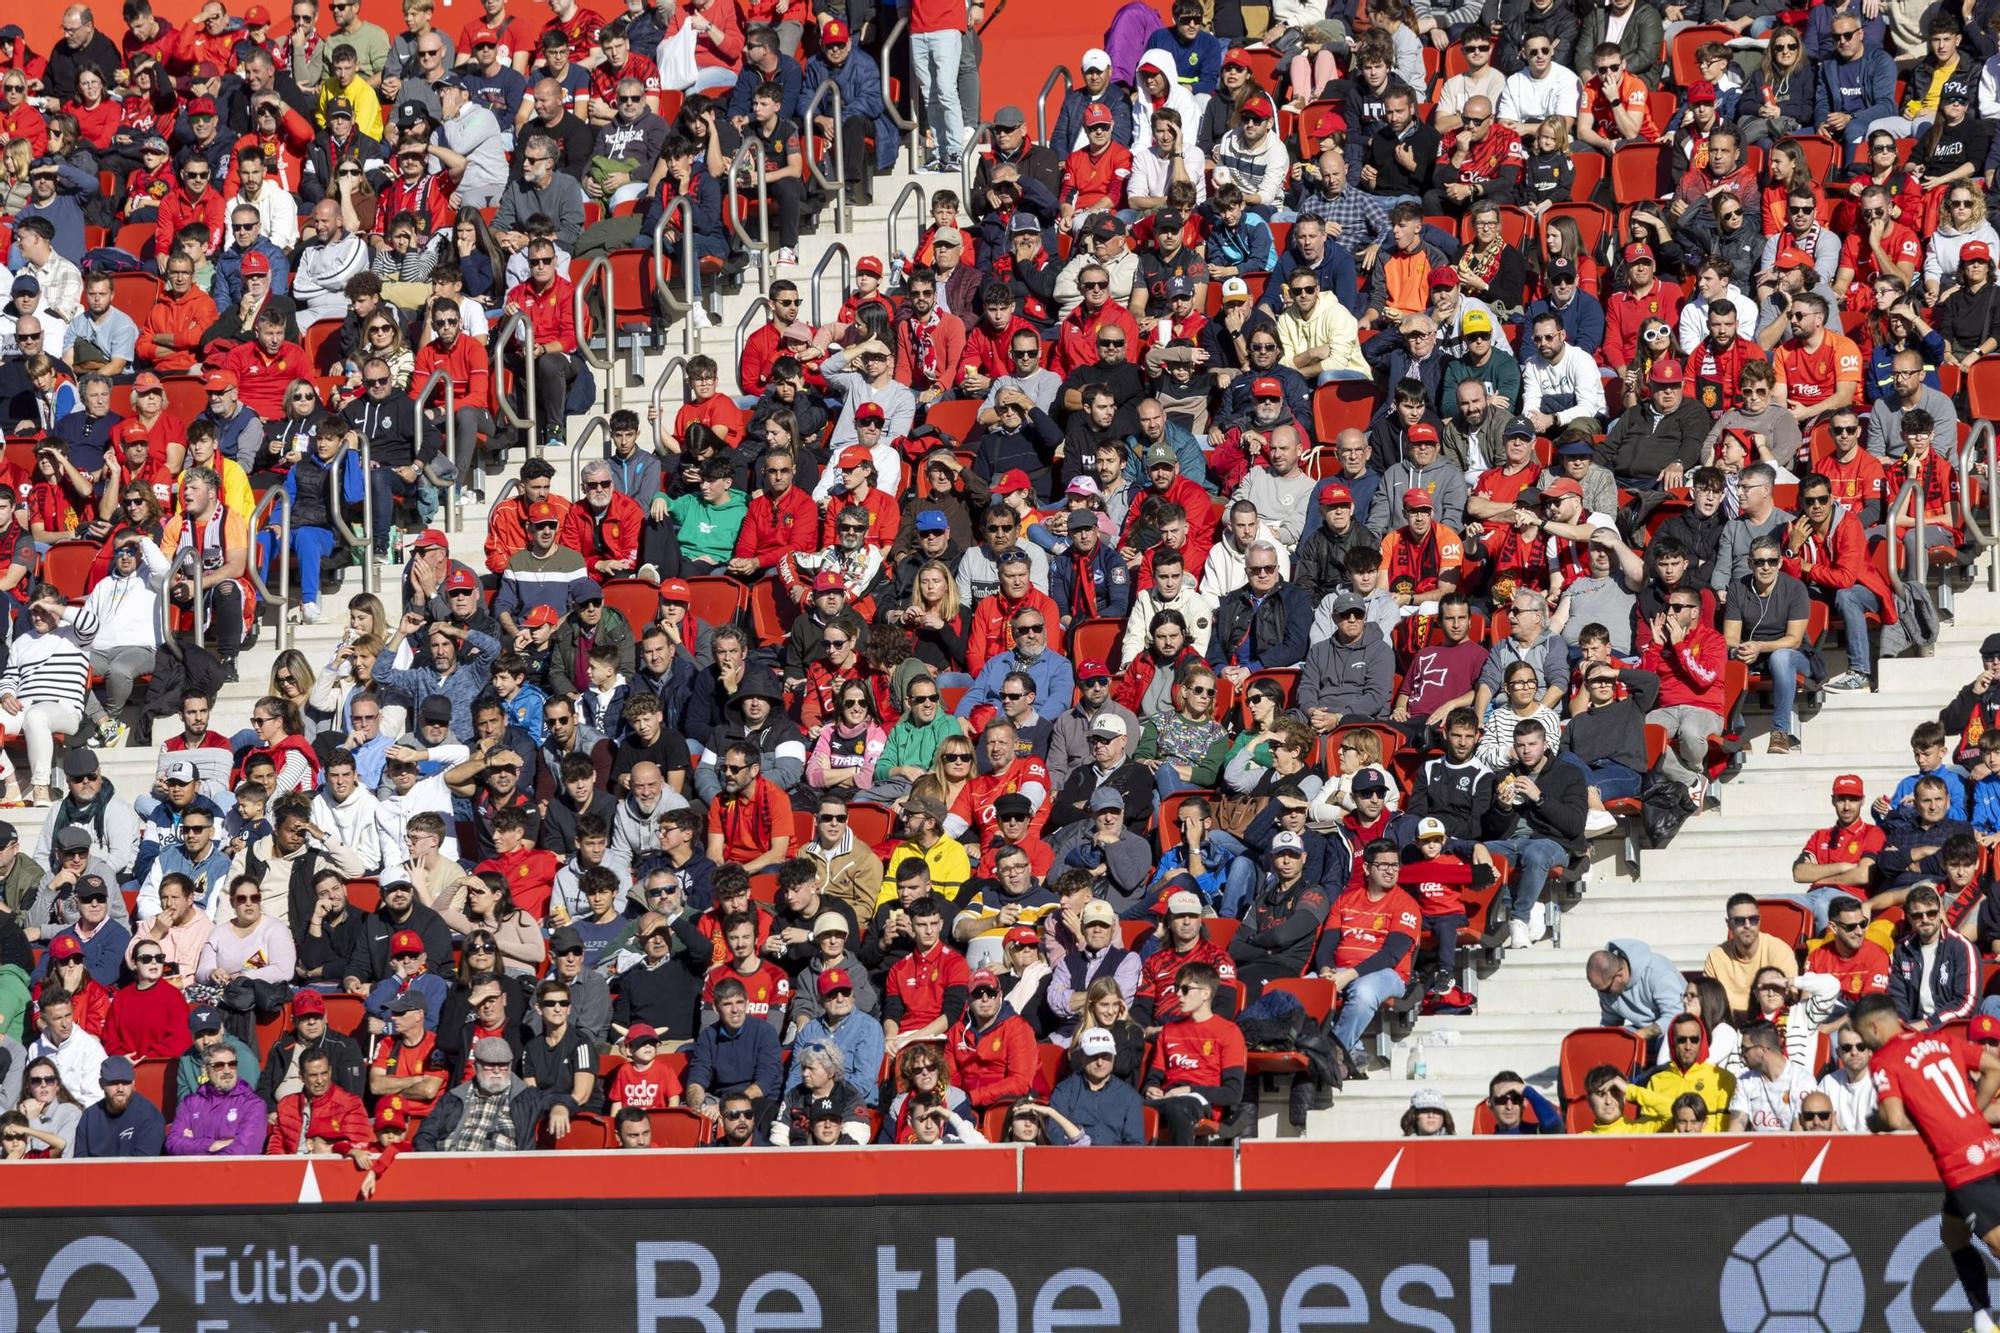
0;1135;1936;1213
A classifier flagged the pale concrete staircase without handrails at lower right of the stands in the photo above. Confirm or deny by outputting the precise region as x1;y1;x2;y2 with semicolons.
1296;570;2000;1139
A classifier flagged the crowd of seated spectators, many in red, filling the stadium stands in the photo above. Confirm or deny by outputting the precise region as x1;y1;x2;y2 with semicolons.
0;0;2000;1179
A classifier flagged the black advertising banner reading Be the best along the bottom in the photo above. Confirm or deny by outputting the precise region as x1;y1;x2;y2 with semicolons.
0;1184;1970;1333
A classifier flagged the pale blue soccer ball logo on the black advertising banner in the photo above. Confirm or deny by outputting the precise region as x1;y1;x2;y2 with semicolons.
1720;1213;1868;1333
